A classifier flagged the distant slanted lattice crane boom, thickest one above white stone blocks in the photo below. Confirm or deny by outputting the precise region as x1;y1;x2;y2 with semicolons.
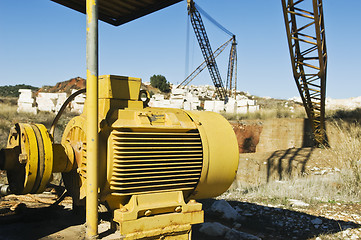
187;0;227;101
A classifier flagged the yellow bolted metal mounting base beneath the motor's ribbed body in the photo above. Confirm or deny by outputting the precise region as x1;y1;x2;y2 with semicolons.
114;191;203;239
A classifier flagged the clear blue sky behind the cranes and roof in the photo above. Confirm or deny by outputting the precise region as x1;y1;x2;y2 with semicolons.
0;0;361;99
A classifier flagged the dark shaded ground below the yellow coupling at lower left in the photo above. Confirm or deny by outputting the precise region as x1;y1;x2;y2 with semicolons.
0;206;110;240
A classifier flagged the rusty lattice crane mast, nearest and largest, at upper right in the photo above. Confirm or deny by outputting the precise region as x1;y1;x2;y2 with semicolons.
282;0;327;145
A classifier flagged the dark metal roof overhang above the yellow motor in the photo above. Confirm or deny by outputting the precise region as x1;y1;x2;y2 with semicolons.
51;0;181;26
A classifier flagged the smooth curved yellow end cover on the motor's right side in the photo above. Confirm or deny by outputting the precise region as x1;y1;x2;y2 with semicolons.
183;111;239;199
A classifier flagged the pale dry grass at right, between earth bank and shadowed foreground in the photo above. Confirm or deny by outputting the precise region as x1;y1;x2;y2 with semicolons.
221;120;361;206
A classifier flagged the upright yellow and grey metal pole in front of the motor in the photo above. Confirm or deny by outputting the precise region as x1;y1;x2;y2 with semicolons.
86;0;98;239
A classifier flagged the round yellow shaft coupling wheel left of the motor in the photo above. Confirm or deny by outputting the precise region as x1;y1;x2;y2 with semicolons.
7;123;53;194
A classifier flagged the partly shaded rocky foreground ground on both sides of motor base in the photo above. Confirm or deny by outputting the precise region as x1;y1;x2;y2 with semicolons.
0;189;361;240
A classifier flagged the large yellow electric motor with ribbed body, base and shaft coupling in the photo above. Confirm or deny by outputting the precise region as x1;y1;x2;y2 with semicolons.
0;75;239;239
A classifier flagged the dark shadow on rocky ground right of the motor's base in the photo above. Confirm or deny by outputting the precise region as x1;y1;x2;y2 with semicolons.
192;199;361;240
